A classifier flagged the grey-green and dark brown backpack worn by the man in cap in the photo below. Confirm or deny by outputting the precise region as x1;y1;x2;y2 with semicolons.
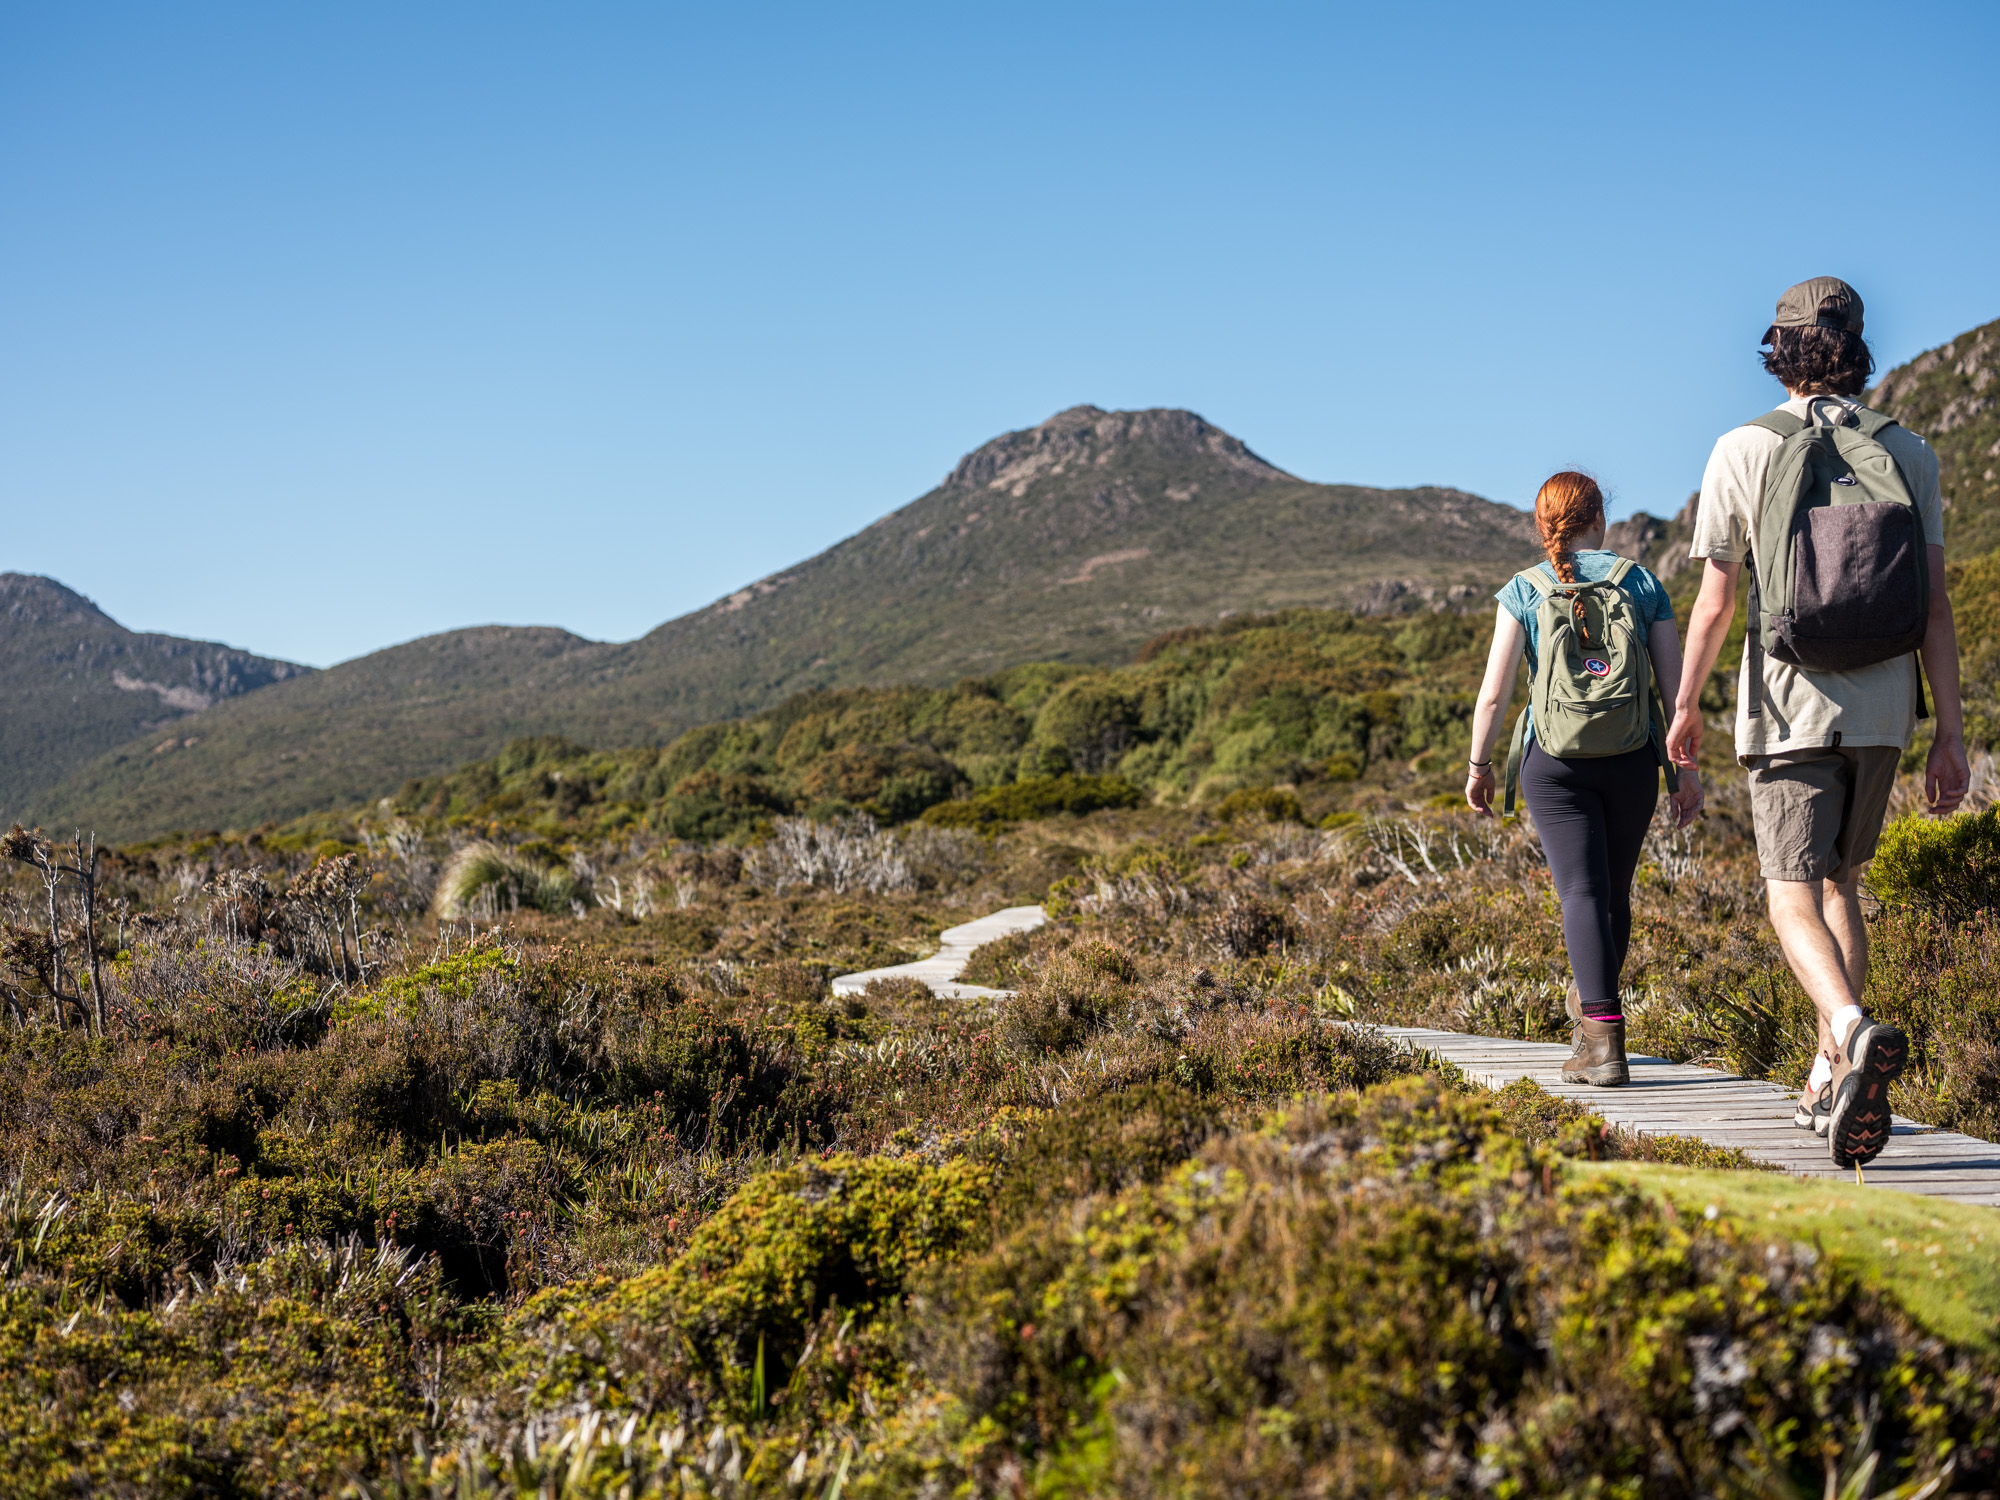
1744;396;1930;718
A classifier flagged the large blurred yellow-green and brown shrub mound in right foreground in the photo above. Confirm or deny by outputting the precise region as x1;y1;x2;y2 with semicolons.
896;1082;2000;1496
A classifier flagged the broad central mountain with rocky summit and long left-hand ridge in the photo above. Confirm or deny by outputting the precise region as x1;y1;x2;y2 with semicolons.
32;406;1536;838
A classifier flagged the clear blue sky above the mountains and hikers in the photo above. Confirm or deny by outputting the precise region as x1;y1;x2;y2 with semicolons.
0;0;2000;664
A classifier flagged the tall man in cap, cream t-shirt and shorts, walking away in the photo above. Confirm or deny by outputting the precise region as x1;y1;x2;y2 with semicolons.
1666;276;1970;1166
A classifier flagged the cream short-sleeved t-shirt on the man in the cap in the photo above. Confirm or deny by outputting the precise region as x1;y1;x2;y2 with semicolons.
1688;396;1944;760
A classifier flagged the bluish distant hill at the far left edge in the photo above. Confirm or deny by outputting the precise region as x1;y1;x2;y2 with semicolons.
0;572;312;818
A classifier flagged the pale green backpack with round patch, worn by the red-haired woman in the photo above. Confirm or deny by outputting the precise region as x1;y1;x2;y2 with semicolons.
1506;558;1680;812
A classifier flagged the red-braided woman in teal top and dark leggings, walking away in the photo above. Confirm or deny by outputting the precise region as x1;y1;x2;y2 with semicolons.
1466;472;1702;1086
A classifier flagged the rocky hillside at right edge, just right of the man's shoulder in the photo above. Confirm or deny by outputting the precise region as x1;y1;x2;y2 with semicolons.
1866;320;2000;558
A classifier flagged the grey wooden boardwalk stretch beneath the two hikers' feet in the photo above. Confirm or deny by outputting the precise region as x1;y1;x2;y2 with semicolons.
1374;1026;2000;1206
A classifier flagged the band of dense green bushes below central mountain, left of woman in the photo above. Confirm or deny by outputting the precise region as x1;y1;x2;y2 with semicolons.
382;610;1484;840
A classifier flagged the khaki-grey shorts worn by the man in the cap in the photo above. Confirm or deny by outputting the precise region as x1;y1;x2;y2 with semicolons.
1748;744;1902;884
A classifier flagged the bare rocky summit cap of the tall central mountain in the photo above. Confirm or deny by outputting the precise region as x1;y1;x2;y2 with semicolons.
942;406;1292;496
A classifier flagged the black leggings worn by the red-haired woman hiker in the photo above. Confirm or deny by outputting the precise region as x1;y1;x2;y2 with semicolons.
1520;744;1660;1016
